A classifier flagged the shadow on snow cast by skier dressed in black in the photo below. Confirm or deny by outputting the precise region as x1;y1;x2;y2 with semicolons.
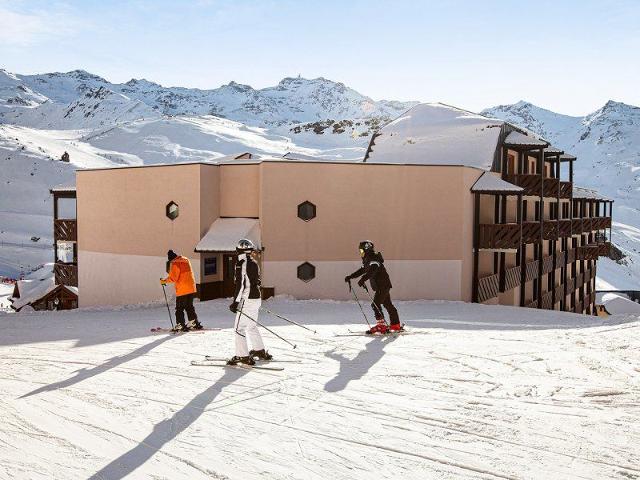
324;336;396;392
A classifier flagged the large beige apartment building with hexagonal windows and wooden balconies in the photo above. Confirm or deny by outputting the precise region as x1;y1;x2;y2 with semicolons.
52;104;612;313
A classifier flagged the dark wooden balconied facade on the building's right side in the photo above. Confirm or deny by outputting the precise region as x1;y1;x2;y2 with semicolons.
472;144;613;315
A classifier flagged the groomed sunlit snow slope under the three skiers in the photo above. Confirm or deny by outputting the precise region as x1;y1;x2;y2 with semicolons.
0;298;640;480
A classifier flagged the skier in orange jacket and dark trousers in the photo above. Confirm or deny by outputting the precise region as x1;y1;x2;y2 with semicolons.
160;250;202;332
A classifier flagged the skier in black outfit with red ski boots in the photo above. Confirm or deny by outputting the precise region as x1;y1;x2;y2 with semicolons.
344;240;402;334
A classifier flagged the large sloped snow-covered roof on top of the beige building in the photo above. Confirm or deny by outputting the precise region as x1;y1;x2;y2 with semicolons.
365;103;505;170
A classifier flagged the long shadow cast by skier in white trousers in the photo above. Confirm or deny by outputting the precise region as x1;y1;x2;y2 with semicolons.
89;368;247;480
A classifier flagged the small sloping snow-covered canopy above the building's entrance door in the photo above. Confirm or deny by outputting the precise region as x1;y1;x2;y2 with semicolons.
195;218;262;252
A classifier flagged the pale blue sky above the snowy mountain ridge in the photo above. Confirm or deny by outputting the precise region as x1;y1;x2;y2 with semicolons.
0;0;640;115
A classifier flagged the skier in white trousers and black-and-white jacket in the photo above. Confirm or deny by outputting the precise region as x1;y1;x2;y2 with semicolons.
227;238;272;365
